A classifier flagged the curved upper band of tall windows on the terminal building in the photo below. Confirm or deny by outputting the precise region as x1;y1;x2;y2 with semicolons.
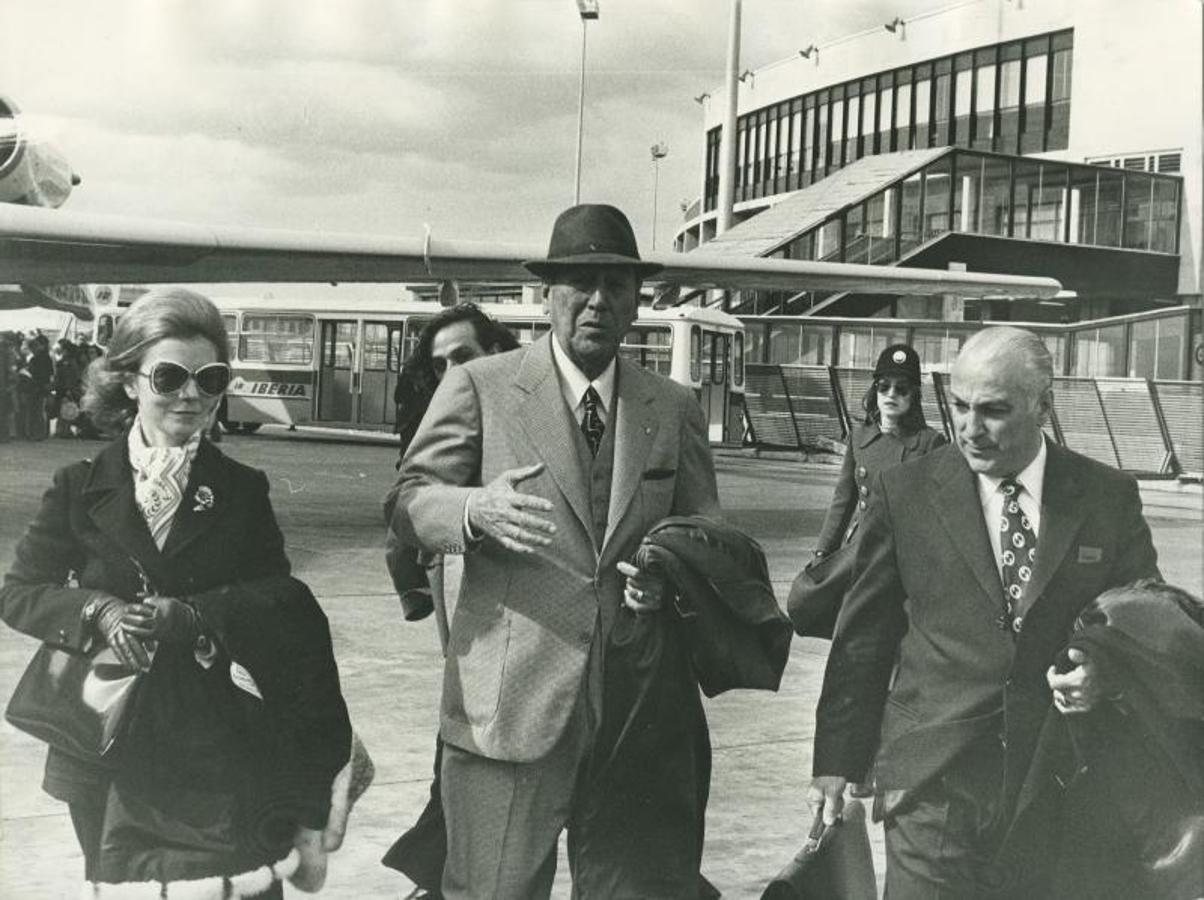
704;30;1074;211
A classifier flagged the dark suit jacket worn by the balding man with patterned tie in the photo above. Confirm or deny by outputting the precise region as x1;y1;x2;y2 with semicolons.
814;445;1158;818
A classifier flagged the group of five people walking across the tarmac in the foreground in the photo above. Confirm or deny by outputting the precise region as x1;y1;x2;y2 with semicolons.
0;205;1204;900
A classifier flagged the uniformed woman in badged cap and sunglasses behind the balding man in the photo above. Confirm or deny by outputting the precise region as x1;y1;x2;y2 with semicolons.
815;344;946;557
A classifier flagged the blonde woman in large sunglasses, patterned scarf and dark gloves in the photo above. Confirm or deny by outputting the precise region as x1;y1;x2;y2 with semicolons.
0;289;352;898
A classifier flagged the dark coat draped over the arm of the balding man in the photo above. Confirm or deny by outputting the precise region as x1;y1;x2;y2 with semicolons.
1021;586;1204;900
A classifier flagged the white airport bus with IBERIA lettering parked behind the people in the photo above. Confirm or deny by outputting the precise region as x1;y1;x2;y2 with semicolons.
149;297;744;444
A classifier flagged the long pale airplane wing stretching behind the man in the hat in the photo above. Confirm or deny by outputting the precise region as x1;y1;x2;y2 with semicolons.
0;203;1061;298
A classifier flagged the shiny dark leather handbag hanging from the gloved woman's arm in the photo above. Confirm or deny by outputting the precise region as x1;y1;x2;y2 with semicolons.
4;644;142;763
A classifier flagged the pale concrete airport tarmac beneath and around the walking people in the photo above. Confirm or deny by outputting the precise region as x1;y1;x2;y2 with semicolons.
0;436;1202;900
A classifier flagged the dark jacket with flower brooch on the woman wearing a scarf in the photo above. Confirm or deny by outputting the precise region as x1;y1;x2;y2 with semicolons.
0;437;289;801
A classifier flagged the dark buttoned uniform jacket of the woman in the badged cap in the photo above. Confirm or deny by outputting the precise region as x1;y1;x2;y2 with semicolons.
815;425;948;553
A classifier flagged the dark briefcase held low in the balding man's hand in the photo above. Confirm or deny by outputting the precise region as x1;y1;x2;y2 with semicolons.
761;800;878;900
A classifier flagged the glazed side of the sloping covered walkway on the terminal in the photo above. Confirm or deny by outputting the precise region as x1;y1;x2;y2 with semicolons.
769;150;1182;265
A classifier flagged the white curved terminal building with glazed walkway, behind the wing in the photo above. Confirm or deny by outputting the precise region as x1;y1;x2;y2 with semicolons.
675;0;1204;378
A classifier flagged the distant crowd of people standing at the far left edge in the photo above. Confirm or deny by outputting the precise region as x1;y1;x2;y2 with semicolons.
0;331;104;442
